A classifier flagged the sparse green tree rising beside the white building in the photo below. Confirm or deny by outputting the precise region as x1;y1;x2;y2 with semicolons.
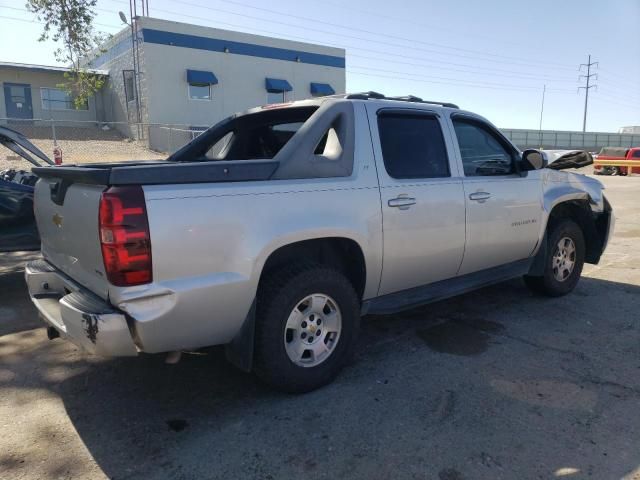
26;0;106;108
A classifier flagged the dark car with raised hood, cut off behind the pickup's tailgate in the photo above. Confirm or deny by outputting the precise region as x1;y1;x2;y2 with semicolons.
0;127;54;252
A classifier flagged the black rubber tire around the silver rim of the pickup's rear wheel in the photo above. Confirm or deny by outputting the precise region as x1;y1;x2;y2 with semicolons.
254;264;360;393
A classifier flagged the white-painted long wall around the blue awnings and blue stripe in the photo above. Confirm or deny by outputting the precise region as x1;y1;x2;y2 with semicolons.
139;18;345;125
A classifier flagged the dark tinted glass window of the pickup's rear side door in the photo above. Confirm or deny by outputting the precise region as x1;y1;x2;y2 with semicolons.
378;113;450;179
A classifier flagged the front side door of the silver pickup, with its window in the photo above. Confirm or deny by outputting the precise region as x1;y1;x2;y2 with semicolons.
451;114;542;275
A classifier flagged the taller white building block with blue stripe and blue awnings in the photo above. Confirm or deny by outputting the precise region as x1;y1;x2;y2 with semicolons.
90;17;345;150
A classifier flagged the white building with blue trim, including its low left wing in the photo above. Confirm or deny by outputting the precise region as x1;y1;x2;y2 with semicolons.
0;17;345;151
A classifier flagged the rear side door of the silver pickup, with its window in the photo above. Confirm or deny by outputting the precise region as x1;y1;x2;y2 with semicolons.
367;105;465;295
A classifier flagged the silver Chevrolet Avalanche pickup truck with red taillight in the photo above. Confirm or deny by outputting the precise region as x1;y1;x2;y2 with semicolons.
18;92;613;392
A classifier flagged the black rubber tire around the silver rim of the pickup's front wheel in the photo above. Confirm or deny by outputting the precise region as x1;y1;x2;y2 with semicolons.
524;219;585;297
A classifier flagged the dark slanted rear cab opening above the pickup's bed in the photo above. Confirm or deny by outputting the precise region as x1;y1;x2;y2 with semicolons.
200;106;318;160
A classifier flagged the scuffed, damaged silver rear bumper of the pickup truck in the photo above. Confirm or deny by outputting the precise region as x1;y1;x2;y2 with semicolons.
25;260;138;356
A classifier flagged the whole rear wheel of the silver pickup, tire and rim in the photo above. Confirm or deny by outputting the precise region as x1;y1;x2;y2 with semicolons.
254;265;360;393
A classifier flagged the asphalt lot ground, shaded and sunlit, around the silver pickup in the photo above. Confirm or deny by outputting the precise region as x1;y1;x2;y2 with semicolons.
0;177;640;480
